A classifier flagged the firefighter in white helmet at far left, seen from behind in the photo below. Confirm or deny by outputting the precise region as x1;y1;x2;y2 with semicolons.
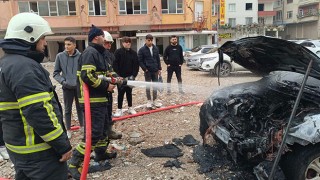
0;13;72;180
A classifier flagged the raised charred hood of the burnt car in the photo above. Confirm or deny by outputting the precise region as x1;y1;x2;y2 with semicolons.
219;36;320;79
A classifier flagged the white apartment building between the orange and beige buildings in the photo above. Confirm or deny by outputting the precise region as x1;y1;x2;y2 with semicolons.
219;0;278;39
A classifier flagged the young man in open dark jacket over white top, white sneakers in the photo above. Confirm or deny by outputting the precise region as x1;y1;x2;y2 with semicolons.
138;34;162;108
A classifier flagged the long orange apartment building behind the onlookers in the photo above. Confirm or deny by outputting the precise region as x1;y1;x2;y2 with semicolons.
0;0;217;61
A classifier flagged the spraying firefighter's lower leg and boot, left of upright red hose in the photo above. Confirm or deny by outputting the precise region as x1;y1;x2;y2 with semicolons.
68;149;83;180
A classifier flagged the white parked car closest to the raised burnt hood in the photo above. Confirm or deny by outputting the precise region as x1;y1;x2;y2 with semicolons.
200;51;248;77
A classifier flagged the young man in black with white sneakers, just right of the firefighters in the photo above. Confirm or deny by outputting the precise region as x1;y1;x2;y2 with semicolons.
113;36;139;117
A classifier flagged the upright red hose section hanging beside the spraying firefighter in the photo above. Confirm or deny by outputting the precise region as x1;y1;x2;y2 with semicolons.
80;83;91;180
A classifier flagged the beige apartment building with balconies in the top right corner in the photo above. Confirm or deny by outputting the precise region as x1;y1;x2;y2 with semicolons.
275;0;320;39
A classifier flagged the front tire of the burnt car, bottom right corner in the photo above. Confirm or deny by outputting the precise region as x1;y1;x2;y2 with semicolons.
280;144;320;180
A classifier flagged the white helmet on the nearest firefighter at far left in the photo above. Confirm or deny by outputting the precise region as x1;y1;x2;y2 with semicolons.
4;12;53;43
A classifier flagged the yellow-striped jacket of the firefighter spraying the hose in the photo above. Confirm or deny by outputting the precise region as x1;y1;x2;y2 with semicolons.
77;43;111;107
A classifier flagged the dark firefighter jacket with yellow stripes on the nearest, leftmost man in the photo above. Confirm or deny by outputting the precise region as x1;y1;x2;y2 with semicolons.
0;40;72;160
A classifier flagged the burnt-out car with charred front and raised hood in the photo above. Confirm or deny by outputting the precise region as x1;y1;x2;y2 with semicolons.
199;36;320;180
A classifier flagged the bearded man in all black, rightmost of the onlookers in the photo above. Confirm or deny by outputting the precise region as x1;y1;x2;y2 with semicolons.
163;35;184;94
